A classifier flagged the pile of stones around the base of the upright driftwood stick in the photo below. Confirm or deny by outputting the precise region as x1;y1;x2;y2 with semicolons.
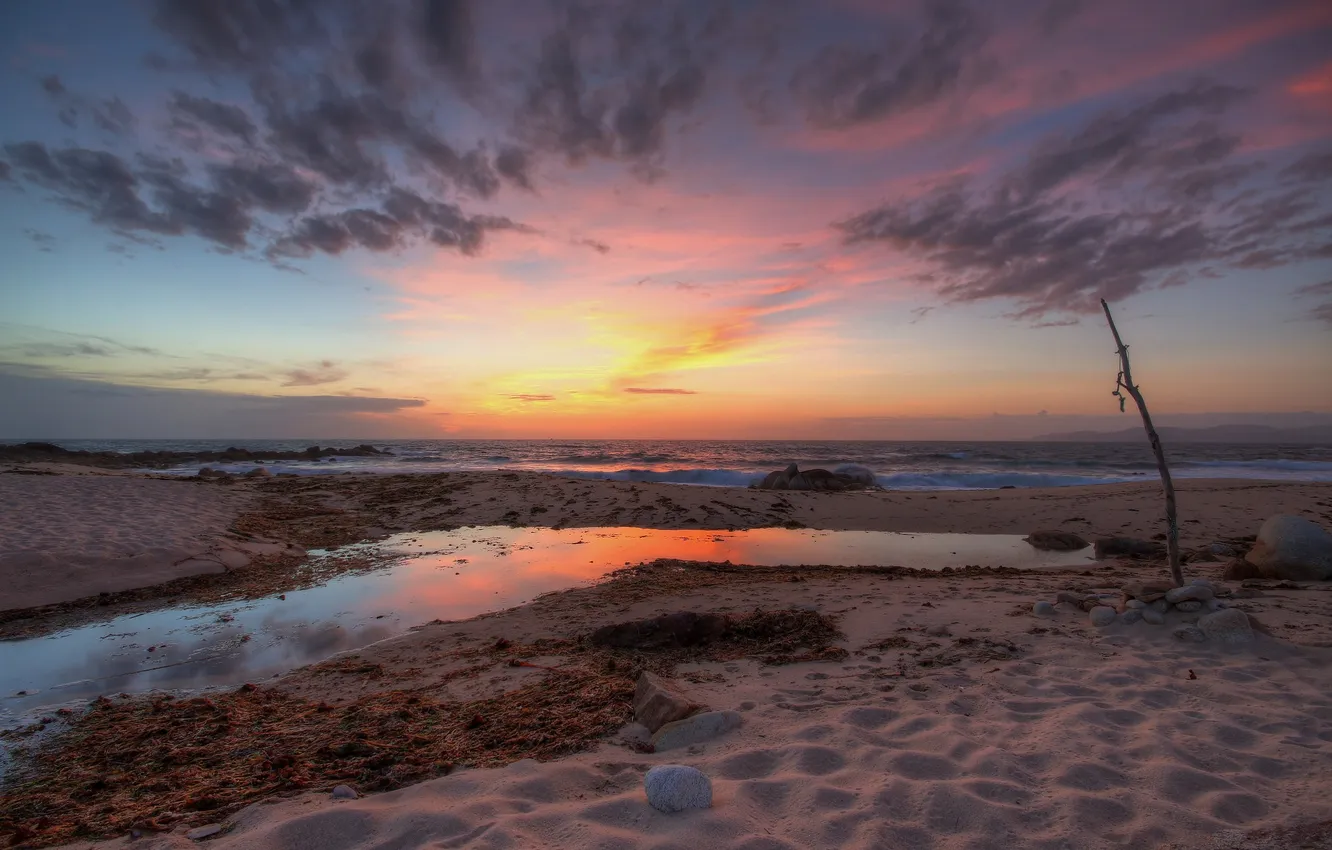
1031;578;1253;646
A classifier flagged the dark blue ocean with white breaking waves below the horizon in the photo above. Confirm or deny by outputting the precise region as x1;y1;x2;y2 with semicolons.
31;440;1332;490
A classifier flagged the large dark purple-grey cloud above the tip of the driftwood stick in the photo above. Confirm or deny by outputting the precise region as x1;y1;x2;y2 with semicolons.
836;84;1327;317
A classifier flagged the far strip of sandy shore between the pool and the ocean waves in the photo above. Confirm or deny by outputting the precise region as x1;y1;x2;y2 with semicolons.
0;465;1332;610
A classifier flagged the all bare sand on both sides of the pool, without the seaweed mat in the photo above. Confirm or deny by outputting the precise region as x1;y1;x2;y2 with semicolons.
0;473;1332;850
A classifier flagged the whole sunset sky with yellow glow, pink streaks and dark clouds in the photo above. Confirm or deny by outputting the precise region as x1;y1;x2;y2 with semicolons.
0;0;1332;440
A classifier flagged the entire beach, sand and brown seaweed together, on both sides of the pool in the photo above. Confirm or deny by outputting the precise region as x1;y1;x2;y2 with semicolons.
0;466;1332;849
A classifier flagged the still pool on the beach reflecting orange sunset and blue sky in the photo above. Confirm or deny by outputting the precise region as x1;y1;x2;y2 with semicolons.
0;526;1091;725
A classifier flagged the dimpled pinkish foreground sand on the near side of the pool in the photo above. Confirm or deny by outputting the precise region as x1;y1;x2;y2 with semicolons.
33;566;1332;850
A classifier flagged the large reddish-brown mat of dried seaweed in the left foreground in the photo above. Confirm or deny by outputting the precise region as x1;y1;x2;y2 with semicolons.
0;669;634;847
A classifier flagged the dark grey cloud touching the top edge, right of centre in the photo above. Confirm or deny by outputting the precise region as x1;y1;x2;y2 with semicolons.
791;0;987;129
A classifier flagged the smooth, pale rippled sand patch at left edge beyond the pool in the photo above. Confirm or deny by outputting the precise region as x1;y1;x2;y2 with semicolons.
0;466;301;610
